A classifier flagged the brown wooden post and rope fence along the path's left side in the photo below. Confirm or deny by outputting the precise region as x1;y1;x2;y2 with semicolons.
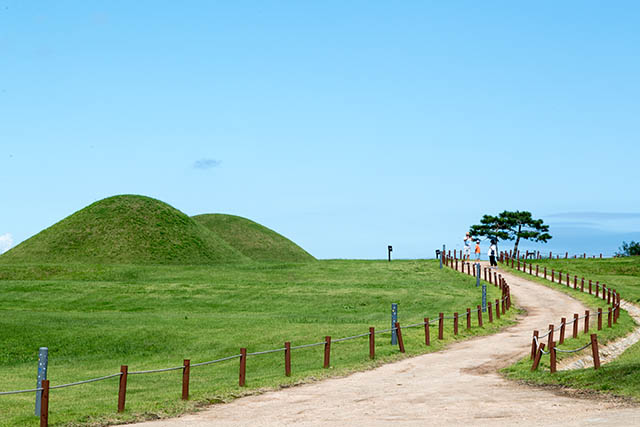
0;262;511;426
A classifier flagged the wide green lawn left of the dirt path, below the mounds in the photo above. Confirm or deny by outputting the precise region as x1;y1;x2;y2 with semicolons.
0;260;510;426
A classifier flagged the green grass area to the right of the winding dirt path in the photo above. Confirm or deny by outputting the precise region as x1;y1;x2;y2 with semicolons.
505;257;640;400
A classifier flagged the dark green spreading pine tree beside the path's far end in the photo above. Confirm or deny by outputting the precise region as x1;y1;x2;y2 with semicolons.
469;211;551;253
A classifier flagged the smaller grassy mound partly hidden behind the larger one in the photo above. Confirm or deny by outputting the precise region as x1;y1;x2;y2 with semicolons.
192;214;315;262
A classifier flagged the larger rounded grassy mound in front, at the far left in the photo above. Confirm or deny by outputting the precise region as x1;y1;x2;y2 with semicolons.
0;195;247;264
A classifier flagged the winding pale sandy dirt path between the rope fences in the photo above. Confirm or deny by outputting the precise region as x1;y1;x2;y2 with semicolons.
135;266;640;427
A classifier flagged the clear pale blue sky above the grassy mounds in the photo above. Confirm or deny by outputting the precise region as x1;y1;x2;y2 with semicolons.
0;0;640;258
